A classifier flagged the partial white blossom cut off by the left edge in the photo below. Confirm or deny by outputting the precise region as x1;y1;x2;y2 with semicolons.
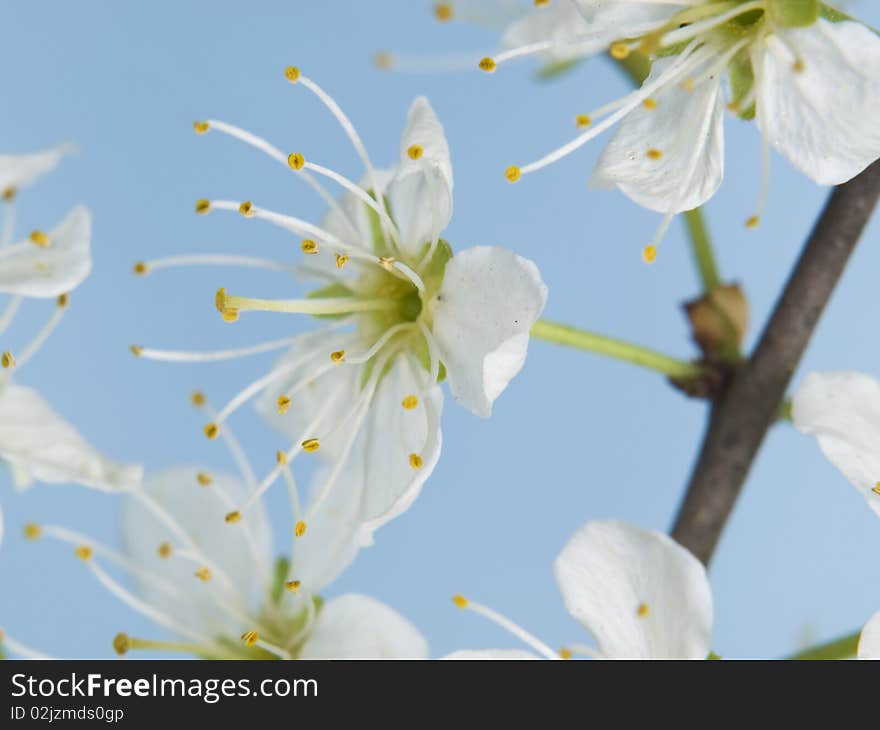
0;146;141;512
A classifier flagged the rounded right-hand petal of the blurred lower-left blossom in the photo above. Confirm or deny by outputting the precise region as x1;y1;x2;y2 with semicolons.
300;593;428;659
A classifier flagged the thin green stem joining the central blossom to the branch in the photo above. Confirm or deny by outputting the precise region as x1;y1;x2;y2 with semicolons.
532;319;703;380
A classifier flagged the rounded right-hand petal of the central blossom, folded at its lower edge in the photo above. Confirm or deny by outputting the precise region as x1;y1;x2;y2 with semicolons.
434;246;547;417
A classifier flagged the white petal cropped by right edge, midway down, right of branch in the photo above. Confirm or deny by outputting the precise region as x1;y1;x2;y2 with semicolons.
792;372;880;514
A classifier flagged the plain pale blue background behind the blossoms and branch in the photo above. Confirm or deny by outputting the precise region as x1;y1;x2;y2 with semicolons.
0;0;880;657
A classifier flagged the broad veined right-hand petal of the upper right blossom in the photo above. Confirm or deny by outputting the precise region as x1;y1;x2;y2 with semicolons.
753;20;880;185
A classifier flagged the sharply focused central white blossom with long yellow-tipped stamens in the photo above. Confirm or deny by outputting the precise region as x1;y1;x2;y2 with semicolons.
133;74;547;545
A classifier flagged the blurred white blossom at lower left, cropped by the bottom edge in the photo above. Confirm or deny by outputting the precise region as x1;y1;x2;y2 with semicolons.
33;468;427;659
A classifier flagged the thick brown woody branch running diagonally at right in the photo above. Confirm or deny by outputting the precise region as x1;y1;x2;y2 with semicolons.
672;162;880;564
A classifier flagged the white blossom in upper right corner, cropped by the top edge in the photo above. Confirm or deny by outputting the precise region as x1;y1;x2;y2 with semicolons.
480;0;880;262
